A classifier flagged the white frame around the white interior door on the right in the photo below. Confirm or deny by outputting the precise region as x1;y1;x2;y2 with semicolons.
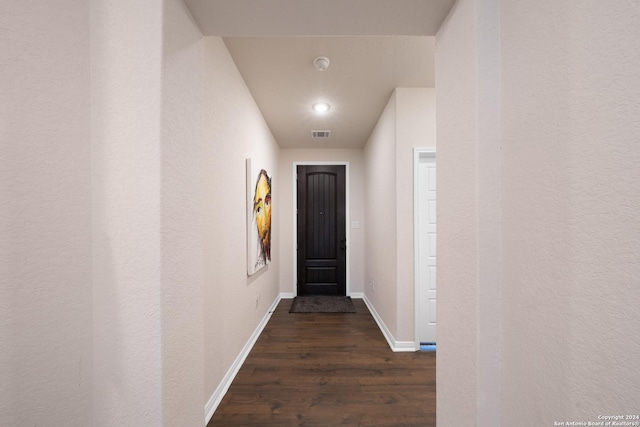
413;147;438;351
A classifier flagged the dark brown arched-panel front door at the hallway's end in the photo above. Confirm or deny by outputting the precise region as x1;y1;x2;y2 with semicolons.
297;165;347;296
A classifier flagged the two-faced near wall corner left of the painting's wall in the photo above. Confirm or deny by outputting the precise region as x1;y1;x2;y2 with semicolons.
91;0;209;425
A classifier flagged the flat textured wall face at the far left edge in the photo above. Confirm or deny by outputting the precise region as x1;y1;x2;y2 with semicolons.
0;0;91;427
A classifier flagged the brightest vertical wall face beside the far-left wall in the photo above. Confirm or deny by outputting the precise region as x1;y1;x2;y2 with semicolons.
91;0;162;426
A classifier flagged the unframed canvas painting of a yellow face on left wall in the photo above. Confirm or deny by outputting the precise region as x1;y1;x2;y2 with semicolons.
247;159;271;275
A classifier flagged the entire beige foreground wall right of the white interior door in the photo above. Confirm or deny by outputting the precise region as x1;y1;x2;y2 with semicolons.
436;0;640;426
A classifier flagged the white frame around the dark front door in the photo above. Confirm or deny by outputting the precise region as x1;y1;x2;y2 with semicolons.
291;161;351;297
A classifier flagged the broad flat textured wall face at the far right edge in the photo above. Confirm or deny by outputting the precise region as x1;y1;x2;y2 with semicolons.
501;1;640;426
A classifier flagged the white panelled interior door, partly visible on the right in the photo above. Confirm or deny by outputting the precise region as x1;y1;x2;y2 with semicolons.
417;154;436;343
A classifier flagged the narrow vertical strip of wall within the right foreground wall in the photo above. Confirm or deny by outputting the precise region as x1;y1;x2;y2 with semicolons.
476;0;503;426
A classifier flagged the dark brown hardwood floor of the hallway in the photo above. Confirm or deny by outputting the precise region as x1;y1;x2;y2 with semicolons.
208;299;436;427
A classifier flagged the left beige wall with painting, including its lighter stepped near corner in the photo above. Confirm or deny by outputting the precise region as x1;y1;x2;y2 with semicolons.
92;5;279;425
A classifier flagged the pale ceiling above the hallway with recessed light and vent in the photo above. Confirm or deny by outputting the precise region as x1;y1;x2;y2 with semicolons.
185;0;455;148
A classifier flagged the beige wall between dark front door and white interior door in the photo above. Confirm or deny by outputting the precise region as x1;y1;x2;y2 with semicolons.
364;88;436;346
